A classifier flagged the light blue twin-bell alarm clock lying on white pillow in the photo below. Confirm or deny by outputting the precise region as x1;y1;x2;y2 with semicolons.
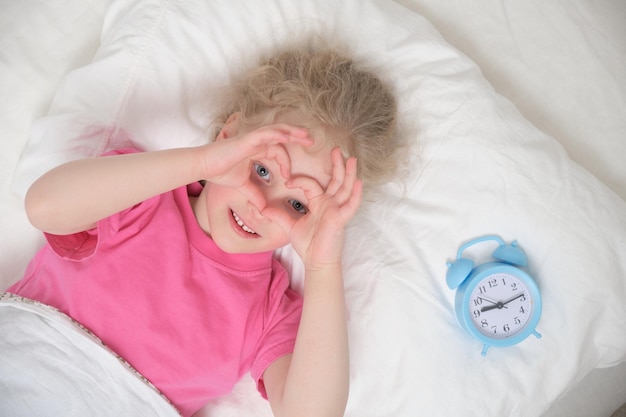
446;235;541;356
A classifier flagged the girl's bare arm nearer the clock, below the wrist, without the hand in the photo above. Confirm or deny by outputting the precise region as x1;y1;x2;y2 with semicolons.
263;265;350;417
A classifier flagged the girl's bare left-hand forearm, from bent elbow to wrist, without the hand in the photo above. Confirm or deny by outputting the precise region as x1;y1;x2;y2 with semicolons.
26;148;205;234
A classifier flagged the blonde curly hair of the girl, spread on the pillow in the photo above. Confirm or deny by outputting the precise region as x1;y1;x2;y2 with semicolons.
214;48;398;184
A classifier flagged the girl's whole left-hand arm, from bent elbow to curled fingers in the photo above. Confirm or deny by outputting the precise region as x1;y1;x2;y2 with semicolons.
25;125;311;234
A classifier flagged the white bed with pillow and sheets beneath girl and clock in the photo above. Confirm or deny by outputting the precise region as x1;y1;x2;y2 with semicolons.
0;0;626;417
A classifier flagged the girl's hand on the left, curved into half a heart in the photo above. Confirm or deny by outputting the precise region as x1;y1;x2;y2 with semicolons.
202;124;313;209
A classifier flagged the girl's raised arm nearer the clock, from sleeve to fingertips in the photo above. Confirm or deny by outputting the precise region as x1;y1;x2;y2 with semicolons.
262;149;362;417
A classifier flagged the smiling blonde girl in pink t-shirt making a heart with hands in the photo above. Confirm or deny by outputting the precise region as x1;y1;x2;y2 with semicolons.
5;52;395;416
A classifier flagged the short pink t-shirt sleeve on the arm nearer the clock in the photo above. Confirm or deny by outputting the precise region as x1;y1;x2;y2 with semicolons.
251;267;302;399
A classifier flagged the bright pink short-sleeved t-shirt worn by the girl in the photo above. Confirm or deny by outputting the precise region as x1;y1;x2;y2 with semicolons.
8;154;302;416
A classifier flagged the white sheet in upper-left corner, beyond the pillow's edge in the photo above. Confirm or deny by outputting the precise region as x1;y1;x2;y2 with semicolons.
0;0;109;289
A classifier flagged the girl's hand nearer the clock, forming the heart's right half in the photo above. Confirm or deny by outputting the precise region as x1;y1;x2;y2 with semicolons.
262;148;363;270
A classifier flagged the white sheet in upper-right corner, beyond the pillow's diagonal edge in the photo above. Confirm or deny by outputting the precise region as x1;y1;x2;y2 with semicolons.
396;0;626;199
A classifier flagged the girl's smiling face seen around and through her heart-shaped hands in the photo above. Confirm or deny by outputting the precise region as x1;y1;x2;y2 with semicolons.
194;112;332;253
